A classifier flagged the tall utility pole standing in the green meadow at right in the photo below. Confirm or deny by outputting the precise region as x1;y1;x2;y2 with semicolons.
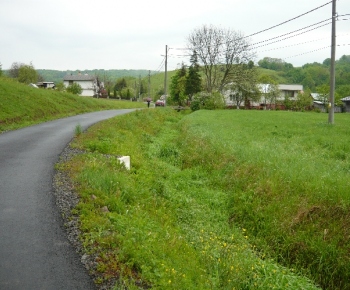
328;0;337;124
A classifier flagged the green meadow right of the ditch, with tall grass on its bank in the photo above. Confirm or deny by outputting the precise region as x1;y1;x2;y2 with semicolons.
183;111;350;289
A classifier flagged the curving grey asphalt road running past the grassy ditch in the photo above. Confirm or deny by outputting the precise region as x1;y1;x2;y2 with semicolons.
0;110;132;290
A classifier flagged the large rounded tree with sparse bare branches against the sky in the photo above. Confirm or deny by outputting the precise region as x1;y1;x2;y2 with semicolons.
187;25;255;92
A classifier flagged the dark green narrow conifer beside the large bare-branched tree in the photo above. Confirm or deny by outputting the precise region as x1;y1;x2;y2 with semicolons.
185;51;202;101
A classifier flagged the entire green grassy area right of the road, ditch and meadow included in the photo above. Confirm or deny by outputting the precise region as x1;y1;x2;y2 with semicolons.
54;109;350;289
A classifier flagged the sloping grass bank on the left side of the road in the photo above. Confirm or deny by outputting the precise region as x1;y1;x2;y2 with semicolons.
0;77;145;133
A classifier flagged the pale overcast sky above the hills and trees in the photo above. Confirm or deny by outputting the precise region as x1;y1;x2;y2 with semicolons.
0;0;350;71
